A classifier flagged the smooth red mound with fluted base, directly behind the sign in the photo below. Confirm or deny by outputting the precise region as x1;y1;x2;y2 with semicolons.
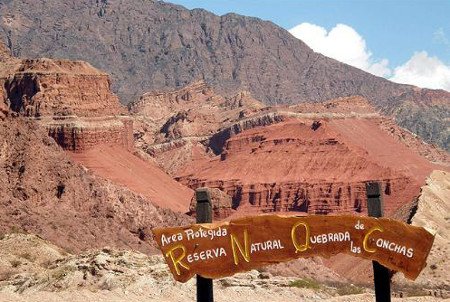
177;118;442;214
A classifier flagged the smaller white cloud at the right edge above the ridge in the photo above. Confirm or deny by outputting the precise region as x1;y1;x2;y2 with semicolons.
390;51;450;91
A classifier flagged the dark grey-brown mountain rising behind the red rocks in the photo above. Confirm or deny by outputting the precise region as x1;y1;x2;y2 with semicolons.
0;0;450;150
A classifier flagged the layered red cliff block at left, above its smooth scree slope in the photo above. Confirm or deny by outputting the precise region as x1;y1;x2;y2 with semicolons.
0;58;134;152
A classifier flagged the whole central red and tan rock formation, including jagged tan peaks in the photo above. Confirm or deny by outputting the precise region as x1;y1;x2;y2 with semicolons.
129;82;450;218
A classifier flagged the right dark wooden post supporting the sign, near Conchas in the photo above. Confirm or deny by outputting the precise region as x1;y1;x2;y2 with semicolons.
366;182;391;302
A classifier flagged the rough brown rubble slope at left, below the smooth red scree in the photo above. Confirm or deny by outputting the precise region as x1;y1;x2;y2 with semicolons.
0;117;191;253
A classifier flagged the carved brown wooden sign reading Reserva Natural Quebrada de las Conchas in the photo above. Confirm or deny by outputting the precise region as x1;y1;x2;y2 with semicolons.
153;215;434;282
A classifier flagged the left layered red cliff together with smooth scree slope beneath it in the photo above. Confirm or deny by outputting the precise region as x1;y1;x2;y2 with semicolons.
1;46;193;213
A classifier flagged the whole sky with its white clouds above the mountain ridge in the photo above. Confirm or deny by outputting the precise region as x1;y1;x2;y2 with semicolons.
169;0;450;90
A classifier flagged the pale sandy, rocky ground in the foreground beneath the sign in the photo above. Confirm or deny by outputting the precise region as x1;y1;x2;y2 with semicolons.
0;234;448;302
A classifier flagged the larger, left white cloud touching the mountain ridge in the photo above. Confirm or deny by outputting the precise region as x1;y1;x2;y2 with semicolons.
289;23;391;76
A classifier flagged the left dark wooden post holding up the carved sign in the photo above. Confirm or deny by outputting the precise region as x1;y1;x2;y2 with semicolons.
195;188;214;302
